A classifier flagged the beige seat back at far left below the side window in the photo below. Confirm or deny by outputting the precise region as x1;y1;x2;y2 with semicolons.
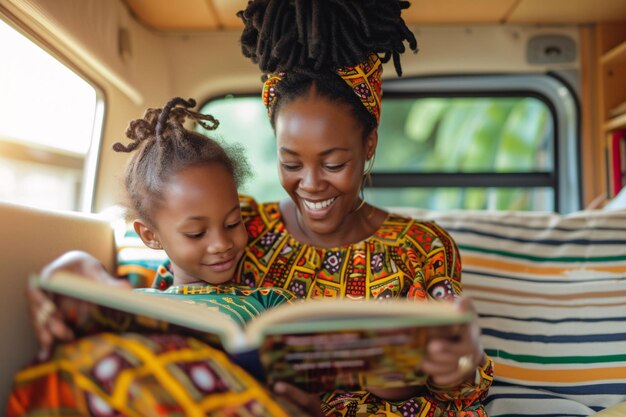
0;203;115;413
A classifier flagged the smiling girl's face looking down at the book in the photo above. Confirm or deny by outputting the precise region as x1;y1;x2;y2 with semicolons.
136;163;248;285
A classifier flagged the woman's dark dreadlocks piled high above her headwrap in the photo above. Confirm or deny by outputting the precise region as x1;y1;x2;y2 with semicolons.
237;0;417;136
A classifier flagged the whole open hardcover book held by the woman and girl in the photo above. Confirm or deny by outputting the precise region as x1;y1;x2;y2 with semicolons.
35;272;472;392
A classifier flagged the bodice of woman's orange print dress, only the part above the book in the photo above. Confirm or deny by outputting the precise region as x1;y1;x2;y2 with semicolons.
238;196;461;300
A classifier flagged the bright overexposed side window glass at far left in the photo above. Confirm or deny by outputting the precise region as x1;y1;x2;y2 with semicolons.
0;20;102;211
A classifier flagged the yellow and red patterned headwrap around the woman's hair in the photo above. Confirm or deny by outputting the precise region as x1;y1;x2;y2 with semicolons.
263;54;383;123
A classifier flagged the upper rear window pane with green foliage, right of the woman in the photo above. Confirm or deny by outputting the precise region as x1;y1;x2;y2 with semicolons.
375;97;554;173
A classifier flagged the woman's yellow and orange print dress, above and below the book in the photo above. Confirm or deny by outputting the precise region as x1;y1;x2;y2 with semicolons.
239;196;493;417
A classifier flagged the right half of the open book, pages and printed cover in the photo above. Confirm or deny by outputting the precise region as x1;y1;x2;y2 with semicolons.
243;300;473;392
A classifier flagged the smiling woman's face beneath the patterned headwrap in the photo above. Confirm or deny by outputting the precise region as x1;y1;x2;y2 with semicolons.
276;94;377;235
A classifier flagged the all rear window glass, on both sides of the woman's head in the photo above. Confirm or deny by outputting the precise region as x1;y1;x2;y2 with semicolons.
203;91;556;211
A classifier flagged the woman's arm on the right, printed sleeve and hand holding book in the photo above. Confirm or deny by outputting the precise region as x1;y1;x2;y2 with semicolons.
368;222;491;403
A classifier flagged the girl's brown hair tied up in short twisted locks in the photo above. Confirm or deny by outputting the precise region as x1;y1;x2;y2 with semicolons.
113;97;250;223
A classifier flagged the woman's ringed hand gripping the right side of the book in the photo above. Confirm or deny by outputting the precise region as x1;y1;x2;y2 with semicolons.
422;297;485;387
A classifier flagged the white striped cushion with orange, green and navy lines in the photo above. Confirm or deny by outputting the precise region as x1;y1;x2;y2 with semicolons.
394;209;626;417
